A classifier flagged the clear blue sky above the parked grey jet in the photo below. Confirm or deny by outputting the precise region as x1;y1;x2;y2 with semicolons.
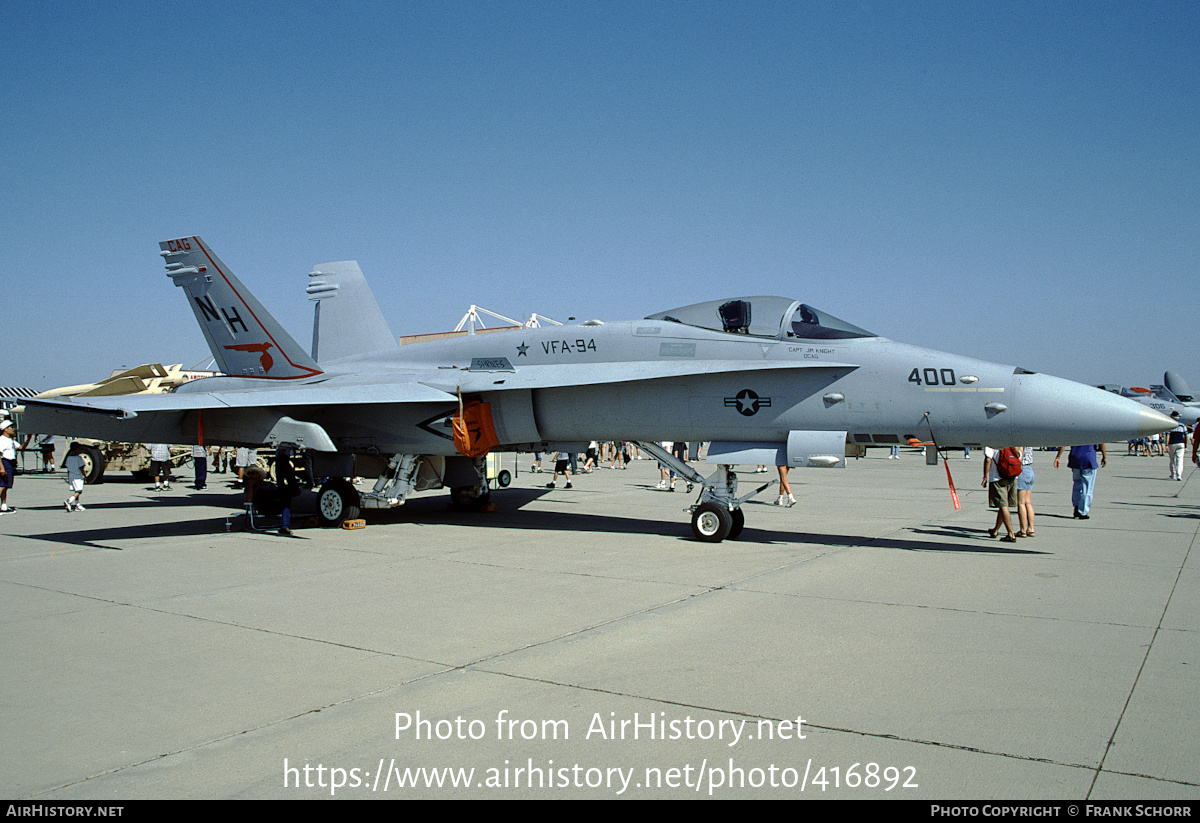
0;0;1200;390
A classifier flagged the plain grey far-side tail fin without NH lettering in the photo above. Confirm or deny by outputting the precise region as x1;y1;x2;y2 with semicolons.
307;260;397;362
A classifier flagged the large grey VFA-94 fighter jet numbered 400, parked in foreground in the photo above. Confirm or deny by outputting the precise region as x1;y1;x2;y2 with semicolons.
18;236;1175;542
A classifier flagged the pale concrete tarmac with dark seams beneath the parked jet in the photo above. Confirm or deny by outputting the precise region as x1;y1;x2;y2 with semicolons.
0;444;1200;800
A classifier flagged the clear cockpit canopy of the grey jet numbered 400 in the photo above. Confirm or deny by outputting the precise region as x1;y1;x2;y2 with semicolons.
646;296;877;340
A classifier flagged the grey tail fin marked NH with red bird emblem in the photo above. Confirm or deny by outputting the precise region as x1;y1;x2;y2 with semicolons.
158;238;322;380
